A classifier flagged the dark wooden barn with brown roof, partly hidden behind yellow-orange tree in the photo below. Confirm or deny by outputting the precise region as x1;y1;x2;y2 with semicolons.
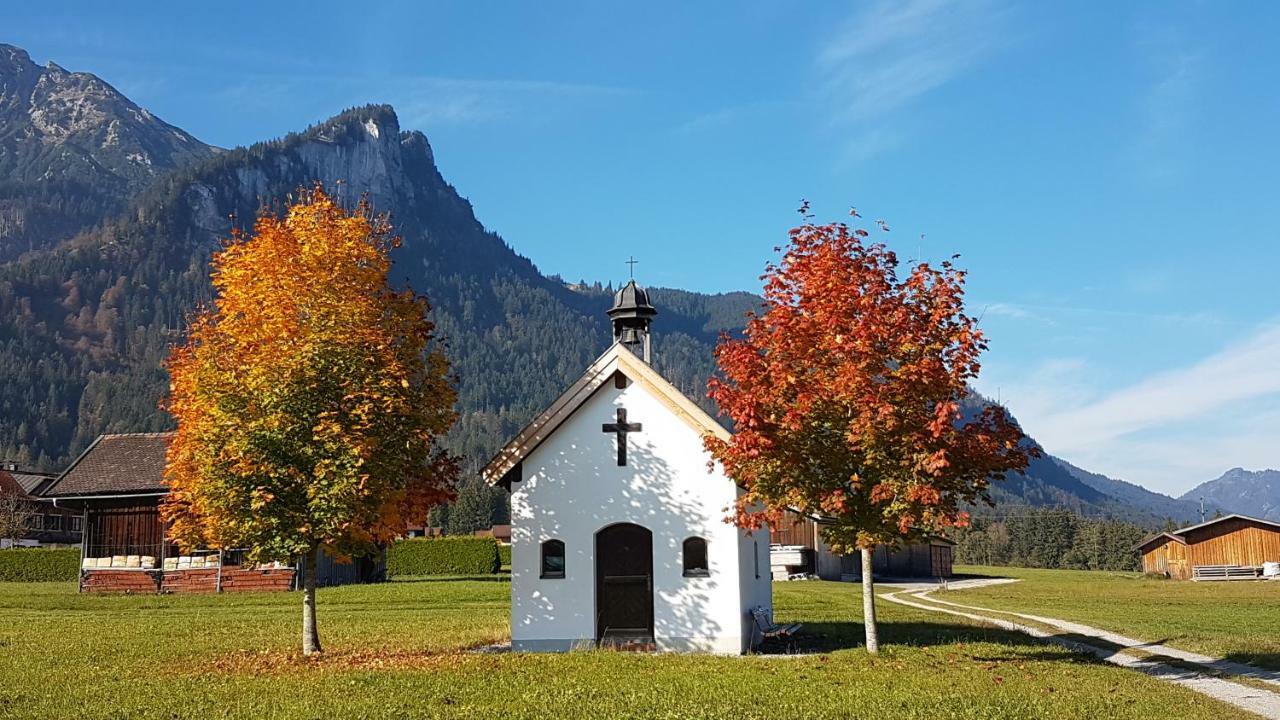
41;433;385;593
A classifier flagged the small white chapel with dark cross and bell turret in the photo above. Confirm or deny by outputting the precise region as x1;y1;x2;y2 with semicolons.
484;281;773;655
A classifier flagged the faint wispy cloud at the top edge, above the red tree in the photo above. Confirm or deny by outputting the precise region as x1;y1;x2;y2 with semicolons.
817;0;1005;139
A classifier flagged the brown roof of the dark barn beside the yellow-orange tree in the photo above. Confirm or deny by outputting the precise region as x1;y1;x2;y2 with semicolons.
44;433;173;497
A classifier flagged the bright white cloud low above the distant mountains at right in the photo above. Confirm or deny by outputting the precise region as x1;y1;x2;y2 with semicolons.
980;324;1280;493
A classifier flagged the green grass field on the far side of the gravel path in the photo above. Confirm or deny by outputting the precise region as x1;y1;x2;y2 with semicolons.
937;566;1280;670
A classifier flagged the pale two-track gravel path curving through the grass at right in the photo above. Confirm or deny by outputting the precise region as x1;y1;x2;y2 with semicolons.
881;578;1280;720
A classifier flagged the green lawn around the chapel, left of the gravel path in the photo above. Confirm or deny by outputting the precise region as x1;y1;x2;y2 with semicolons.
0;577;1259;720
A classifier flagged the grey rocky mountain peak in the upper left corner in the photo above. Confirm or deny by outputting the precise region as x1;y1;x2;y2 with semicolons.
0;45;214;259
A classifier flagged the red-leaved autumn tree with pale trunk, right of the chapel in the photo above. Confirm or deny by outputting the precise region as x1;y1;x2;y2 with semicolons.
707;204;1036;652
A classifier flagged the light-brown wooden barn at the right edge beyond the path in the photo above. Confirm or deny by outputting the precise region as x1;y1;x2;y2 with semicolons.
1134;515;1280;580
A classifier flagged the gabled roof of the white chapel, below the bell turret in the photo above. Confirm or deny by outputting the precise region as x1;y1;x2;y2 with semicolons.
480;342;732;486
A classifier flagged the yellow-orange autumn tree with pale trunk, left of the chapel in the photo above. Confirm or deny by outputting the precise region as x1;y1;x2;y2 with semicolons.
161;186;457;655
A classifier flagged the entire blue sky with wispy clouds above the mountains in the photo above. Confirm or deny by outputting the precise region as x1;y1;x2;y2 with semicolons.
10;0;1280;492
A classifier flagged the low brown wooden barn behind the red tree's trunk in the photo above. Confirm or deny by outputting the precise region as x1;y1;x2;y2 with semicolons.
771;512;955;580
